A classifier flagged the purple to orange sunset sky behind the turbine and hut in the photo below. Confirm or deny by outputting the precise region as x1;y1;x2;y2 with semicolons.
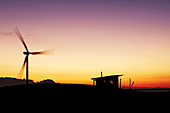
0;0;170;87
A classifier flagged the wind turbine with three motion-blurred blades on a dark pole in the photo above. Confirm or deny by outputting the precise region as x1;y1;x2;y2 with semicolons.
14;27;50;84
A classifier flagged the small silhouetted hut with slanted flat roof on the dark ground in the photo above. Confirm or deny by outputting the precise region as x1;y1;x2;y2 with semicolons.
91;75;123;89
